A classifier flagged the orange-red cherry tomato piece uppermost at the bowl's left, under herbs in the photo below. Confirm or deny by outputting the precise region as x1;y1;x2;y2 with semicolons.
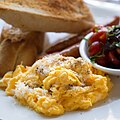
88;31;107;45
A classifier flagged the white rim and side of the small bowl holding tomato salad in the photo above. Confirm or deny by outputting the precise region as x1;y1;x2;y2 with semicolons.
79;32;120;76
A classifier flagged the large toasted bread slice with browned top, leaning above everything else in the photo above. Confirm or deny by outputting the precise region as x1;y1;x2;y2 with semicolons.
0;0;94;33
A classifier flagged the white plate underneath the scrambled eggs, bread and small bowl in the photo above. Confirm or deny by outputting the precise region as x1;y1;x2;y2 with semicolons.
0;2;120;120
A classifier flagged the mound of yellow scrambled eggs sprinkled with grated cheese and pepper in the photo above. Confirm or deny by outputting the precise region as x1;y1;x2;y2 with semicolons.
0;55;112;116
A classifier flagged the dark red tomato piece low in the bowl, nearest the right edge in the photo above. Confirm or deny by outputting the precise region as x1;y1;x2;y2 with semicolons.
108;51;120;65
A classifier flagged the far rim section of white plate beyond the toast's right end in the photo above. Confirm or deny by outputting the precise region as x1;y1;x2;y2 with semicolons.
84;0;120;24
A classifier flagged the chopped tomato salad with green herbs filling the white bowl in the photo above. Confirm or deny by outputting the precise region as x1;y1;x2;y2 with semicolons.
88;25;120;69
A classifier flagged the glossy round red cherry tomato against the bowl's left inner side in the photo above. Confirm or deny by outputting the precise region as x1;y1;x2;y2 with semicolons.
88;41;102;56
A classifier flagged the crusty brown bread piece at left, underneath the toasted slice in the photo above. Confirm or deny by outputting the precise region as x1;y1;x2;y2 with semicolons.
0;27;44;76
